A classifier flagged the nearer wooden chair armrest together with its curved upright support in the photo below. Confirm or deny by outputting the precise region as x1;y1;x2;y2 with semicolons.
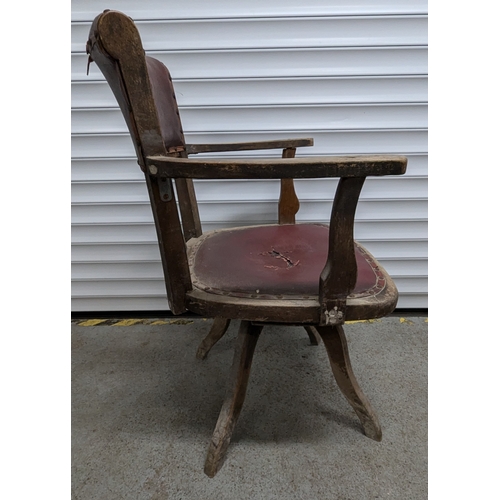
146;155;408;326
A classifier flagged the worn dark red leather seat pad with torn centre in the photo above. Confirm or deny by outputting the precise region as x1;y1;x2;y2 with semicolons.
190;224;386;299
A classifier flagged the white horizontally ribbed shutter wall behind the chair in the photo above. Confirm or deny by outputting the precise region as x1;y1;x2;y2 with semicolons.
72;0;427;311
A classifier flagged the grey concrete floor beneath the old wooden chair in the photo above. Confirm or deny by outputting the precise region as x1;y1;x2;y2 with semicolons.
72;316;427;500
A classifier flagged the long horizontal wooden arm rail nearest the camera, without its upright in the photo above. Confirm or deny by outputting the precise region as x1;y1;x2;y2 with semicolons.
146;155;408;179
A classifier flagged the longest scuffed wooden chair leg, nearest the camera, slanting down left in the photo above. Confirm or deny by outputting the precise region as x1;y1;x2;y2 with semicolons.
205;321;262;477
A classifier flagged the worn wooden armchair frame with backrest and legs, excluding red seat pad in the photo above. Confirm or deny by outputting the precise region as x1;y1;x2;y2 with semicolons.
87;10;407;477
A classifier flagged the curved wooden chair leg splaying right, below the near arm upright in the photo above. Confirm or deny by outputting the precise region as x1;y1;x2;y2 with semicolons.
316;325;382;441
